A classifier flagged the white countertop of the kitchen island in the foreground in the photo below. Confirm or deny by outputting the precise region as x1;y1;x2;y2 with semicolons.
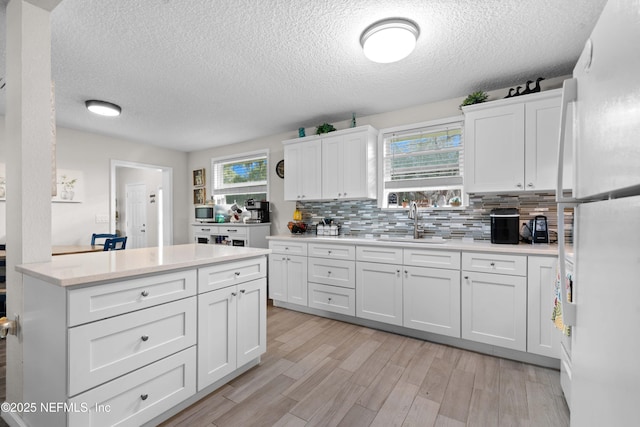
16;243;271;286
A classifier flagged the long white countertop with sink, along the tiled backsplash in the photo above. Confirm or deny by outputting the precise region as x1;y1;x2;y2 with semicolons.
267;234;573;256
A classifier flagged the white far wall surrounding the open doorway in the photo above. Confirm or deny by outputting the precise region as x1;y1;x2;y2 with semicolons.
0;117;191;245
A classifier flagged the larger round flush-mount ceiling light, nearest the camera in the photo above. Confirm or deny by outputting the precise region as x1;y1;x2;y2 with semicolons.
360;18;420;64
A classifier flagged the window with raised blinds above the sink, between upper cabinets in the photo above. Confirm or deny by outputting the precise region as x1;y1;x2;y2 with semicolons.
379;117;464;208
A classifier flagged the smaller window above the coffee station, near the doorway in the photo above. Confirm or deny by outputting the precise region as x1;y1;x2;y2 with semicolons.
211;150;269;206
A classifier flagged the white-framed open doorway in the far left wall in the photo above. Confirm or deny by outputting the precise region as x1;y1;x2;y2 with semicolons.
110;160;173;248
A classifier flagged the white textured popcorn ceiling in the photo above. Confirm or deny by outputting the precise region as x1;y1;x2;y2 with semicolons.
0;0;606;151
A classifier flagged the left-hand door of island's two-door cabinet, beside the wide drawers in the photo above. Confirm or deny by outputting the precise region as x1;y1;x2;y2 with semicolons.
198;286;238;391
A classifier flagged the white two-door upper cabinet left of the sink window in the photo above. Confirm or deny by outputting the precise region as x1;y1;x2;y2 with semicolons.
283;126;378;201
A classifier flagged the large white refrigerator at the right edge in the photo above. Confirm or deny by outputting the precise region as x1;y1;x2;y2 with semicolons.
556;0;640;427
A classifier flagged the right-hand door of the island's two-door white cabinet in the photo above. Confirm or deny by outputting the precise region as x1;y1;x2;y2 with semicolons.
237;279;267;367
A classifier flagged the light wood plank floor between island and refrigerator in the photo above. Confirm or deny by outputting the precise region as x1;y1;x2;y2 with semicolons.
162;306;569;427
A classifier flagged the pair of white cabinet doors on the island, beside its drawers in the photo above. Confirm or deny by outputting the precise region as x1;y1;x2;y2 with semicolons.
198;278;267;391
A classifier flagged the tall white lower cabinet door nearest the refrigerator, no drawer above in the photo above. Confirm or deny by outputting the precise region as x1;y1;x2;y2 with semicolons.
527;256;561;359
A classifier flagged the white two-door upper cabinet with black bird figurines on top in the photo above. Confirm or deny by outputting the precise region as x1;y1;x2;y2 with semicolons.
463;90;572;193
